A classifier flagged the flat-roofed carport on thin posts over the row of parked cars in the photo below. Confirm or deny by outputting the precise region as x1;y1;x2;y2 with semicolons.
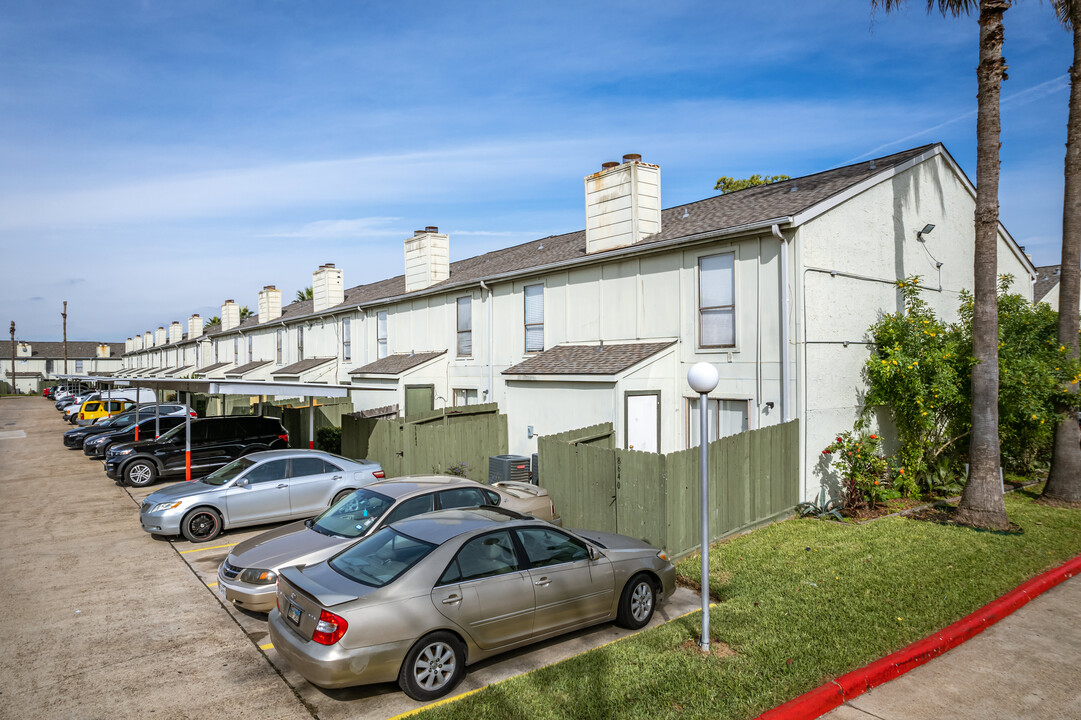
59;375;350;481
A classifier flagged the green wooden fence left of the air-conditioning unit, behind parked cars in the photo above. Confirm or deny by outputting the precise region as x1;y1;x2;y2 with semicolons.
342;403;507;482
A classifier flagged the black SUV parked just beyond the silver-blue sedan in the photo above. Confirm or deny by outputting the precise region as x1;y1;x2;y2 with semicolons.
105;415;289;488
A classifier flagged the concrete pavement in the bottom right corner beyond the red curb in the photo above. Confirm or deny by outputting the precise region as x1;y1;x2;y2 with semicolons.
822;577;1081;720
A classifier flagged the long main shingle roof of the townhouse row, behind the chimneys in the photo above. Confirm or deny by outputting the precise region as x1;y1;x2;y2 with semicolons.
172;145;934;345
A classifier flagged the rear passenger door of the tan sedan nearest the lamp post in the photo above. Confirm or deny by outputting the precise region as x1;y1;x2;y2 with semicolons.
431;530;534;650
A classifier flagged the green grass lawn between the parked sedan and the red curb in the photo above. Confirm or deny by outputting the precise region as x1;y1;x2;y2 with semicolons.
423;485;1081;720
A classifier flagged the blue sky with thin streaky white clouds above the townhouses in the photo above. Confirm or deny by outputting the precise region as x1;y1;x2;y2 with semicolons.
0;0;1071;341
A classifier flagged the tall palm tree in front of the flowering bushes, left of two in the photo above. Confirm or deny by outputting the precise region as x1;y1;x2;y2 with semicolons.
871;0;1012;530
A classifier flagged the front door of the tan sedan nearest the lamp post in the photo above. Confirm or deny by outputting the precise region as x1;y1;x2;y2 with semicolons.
515;528;613;636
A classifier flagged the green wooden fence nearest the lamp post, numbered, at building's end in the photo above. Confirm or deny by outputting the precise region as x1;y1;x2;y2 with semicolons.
538;421;799;557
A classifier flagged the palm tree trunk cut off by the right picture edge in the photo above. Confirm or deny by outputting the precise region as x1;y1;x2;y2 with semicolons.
1043;8;1081;503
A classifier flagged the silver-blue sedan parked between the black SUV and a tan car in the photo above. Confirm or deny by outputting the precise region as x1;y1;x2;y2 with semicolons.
139;450;384;543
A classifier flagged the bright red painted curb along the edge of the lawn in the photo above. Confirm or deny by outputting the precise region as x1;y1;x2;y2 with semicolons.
756;555;1081;720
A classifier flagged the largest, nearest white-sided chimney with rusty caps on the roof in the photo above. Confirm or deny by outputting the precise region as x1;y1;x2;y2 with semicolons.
586;155;660;253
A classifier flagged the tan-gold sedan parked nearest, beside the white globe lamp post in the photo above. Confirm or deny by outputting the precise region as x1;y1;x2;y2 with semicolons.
269;508;676;701
